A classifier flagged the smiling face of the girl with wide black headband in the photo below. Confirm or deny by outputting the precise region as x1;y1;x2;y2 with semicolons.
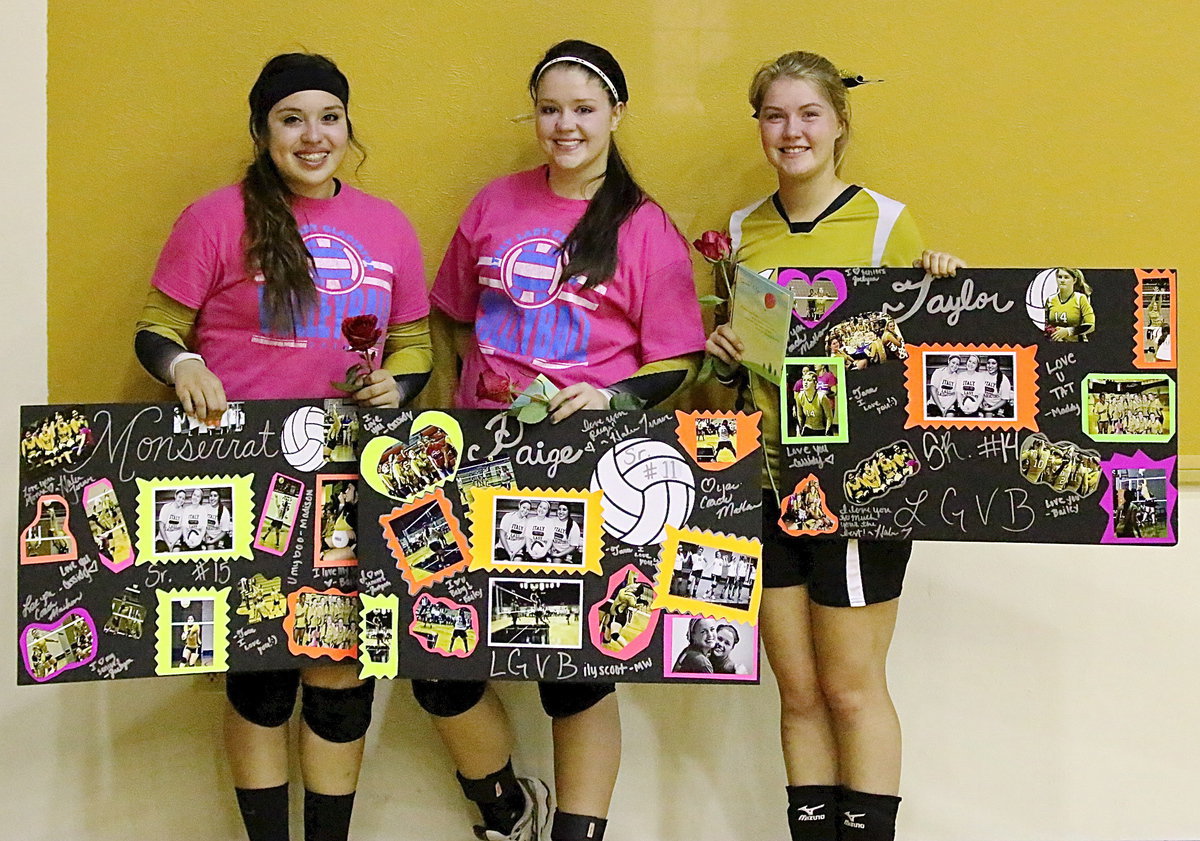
265;90;349;198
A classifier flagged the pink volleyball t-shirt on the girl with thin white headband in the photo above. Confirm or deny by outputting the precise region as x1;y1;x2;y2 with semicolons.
432;167;704;408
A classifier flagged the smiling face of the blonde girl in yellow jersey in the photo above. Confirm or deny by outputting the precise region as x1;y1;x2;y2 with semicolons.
758;76;844;182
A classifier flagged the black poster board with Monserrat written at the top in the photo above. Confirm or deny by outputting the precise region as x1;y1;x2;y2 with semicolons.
17;401;359;684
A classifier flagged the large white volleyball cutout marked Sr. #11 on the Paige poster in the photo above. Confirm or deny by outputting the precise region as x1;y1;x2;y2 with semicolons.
592;438;696;546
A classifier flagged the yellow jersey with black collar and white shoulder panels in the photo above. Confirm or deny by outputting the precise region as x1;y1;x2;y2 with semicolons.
730;186;924;487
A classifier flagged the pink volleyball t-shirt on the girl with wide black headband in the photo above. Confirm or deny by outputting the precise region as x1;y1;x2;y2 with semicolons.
151;184;430;400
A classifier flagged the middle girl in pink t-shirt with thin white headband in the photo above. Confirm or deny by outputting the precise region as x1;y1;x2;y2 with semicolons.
422;41;704;841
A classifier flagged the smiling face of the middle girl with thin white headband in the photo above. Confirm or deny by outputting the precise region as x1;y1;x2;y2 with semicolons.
534;64;625;185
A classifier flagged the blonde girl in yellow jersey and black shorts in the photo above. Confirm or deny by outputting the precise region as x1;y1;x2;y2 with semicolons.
707;53;964;841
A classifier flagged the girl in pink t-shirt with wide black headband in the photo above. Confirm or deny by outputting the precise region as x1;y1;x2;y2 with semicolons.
134;53;432;841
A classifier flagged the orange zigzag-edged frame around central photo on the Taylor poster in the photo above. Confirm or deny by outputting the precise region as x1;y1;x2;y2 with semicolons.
904;344;1039;432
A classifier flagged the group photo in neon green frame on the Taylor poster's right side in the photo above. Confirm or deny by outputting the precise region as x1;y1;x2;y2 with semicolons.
1079;372;1178;444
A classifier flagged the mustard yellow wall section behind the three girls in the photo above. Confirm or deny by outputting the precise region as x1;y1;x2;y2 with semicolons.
48;0;1200;452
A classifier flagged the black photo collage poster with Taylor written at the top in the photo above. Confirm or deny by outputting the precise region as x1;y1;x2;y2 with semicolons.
768;266;1178;546
